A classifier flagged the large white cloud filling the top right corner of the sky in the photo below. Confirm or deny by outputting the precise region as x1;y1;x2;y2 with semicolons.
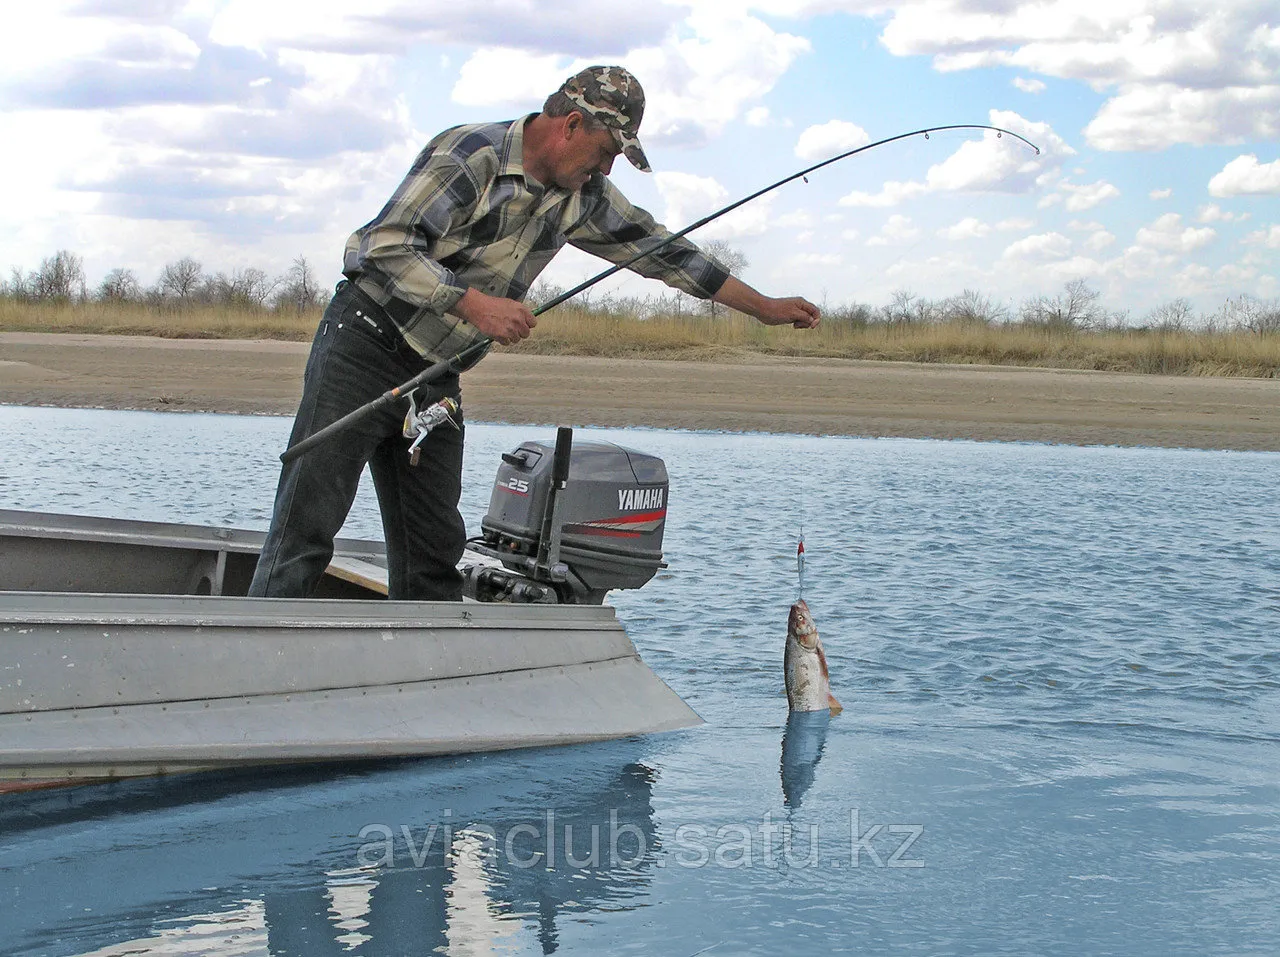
870;0;1280;150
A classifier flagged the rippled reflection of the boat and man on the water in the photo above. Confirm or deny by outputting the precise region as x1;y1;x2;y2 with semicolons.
0;745;659;957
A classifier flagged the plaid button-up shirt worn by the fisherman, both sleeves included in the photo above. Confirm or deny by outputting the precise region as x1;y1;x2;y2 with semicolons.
343;120;728;360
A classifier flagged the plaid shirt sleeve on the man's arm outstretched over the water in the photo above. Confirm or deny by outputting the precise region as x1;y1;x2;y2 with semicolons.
566;175;728;299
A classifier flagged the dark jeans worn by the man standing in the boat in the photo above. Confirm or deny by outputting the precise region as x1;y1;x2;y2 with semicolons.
248;284;466;601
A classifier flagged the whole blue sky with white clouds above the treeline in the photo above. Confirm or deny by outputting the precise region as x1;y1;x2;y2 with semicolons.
0;0;1280;320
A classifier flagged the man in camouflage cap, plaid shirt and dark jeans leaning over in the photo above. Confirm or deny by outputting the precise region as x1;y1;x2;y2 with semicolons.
250;67;818;601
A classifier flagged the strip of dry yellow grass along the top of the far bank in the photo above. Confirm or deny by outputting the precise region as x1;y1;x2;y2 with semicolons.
0;299;1280;379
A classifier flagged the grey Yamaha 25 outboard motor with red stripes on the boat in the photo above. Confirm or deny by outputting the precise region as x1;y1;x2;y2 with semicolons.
462;429;668;605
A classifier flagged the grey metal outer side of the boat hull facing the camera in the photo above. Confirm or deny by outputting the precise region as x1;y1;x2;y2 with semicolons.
0;511;701;791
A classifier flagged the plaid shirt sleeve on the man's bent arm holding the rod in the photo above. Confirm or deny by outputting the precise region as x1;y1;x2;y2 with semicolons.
343;147;480;315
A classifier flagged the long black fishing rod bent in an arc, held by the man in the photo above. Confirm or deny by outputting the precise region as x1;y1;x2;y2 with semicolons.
280;123;1039;462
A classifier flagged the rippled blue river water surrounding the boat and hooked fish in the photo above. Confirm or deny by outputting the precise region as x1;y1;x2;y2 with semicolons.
0;408;1280;957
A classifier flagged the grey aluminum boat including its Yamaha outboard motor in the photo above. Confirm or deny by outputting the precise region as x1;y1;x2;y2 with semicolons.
0;429;701;791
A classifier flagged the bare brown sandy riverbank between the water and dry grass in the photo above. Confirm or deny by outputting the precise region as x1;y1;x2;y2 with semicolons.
0;333;1280;450
